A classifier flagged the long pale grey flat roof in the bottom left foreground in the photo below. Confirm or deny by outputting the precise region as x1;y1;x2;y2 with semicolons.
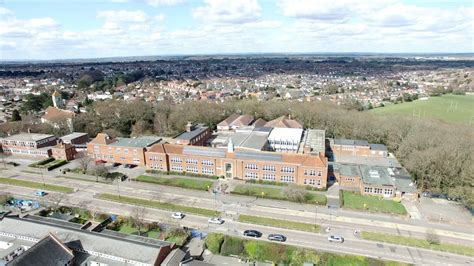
0;215;170;265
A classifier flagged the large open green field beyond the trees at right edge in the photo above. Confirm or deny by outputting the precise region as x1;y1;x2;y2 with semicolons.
370;94;474;124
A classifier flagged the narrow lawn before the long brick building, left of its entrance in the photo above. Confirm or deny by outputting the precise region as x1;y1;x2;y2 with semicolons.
137;175;214;190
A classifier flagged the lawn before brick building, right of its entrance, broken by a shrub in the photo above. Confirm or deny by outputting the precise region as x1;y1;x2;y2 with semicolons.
231;185;326;205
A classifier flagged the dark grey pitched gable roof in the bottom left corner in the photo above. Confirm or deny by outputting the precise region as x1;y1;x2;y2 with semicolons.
7;234;74;266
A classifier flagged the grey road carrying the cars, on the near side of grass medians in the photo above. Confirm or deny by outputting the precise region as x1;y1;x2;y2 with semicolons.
0;185;474;265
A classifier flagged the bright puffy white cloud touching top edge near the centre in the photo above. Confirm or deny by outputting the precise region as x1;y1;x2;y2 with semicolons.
193;0;262;24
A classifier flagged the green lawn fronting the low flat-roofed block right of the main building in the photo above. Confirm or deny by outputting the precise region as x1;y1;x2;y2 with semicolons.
342;191;407;214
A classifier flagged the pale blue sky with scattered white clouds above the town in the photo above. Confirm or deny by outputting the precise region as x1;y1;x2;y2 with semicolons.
0;0;474;60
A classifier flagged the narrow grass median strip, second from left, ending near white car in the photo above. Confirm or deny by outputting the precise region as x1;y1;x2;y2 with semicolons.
99;193;216;217
